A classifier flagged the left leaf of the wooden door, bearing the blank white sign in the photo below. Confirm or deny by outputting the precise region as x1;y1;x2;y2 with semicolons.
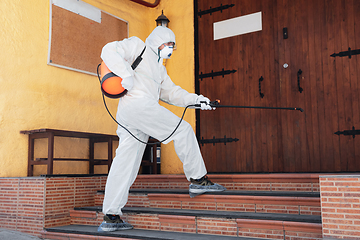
199;1;281;172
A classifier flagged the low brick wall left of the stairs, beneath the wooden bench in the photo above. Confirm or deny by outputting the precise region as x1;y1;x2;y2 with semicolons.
0;176;106;236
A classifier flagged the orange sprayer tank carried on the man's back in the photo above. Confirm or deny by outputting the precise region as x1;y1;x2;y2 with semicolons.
100;62;127;98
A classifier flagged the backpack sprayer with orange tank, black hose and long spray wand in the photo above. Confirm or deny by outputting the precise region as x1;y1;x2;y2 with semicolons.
97;47;304;145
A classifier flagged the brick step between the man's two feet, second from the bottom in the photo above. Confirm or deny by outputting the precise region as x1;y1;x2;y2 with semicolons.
70;207;322;239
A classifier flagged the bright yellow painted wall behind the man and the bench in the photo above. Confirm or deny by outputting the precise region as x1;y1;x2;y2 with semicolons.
0;0;195;177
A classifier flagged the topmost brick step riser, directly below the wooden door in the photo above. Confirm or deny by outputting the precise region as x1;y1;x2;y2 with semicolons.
132;173;320;192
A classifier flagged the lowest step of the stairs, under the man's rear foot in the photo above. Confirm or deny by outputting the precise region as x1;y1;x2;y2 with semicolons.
42;225;265;240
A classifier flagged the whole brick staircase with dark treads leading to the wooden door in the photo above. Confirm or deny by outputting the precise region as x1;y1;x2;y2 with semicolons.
41;174;322;240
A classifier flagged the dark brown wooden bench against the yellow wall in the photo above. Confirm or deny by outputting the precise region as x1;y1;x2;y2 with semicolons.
20;128;158;176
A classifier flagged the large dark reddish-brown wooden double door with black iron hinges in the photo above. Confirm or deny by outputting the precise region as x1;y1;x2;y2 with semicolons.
195;0;360;173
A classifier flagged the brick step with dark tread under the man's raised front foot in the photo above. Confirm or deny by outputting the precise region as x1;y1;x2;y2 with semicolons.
95;189;321;216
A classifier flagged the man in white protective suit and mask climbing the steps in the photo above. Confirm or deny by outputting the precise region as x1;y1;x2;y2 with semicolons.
98;26;225;231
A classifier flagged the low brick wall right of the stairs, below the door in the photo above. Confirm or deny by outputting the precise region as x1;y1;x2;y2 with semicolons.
320;175;360;239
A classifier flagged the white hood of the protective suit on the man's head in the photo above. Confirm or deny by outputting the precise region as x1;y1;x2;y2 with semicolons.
145;26;175;54
